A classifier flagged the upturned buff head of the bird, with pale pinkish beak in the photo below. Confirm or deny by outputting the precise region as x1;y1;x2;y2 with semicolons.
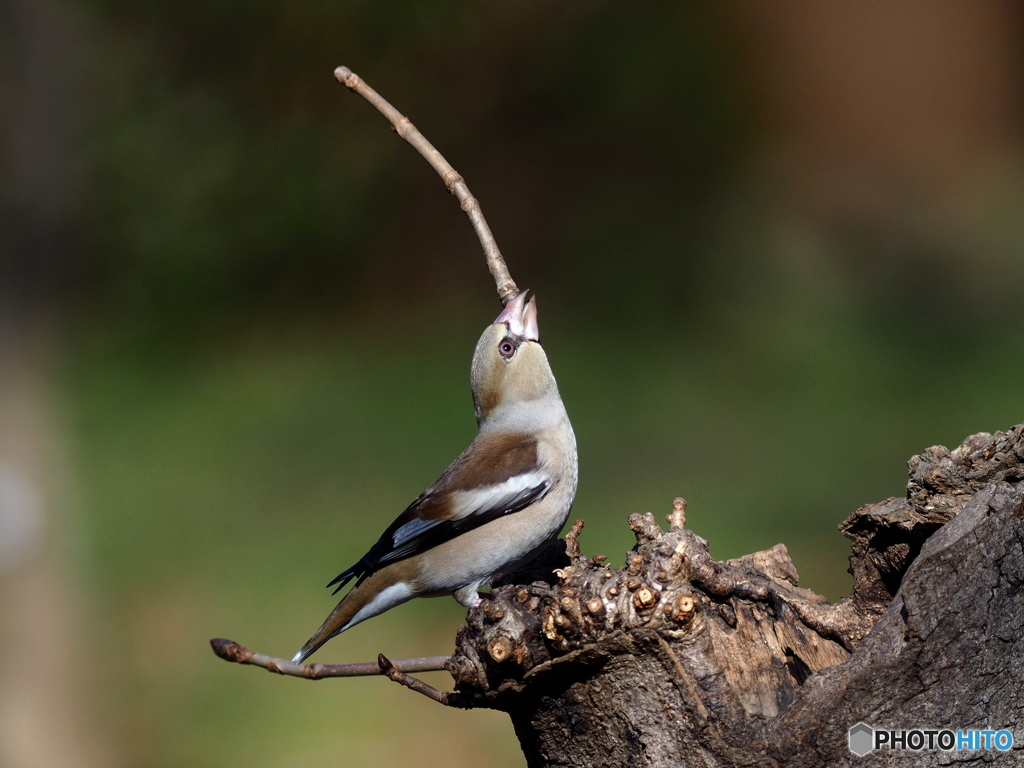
472;291;558;424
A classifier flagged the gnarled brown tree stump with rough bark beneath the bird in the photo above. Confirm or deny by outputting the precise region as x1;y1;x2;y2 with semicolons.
449;425;1024;768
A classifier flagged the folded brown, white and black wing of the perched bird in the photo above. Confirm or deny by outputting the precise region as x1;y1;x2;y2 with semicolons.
328;434;551;592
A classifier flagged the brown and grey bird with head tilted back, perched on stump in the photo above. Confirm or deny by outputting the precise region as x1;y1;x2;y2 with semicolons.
292;291;579;664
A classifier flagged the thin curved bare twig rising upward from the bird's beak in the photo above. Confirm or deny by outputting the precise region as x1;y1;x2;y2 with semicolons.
334;67;519;304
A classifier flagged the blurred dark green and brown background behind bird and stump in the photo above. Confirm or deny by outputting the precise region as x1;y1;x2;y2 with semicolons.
0;0;1024;768
